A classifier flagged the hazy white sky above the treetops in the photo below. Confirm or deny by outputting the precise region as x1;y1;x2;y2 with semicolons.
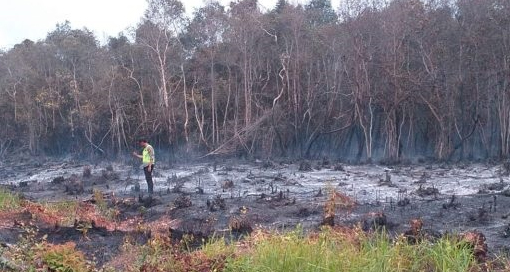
0;0;340;49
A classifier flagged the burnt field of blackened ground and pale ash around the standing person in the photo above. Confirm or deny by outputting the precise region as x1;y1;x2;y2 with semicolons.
0;160;510;264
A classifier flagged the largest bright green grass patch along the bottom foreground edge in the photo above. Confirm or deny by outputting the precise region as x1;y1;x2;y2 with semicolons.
225;229;476;272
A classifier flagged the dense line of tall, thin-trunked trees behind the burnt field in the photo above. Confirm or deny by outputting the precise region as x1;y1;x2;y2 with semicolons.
0;0;510;161
